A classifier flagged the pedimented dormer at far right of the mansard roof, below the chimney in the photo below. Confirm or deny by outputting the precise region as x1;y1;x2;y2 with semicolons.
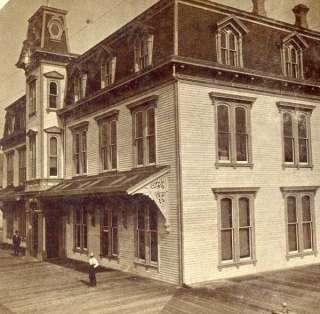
281;34;308;79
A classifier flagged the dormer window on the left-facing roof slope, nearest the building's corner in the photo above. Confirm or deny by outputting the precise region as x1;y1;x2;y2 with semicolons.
134;34;153;72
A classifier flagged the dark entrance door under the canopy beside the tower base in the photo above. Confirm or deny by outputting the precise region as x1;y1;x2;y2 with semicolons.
46;215;61;258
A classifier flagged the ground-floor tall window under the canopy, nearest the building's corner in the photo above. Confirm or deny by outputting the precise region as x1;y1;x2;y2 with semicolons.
136;207;158;264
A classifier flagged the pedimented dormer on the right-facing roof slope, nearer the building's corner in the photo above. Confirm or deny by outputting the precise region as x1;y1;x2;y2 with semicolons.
217;17;248;67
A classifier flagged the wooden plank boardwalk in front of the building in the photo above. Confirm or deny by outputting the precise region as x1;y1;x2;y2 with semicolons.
0;250;320;314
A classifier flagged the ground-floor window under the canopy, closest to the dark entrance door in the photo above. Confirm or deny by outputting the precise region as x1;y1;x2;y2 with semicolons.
74;207;88;251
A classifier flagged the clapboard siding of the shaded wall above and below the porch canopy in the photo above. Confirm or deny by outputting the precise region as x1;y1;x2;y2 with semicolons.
65;83;179;283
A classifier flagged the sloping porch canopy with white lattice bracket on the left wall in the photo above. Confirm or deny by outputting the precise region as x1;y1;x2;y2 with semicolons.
40;166;169;229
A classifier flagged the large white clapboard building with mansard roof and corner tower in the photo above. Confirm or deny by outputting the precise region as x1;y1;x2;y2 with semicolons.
0;0;320;284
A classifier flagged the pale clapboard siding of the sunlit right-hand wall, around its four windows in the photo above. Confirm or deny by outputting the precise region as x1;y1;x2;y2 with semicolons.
179;82;320;283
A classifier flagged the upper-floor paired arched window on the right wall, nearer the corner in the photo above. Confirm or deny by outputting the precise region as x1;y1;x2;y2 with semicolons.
211;94;254;166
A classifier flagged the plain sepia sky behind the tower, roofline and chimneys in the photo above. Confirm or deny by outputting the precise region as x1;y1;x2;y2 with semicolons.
0;0;320;137
